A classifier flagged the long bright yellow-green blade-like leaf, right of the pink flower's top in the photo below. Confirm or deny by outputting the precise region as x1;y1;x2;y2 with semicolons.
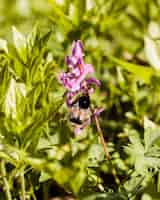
107;56;154;84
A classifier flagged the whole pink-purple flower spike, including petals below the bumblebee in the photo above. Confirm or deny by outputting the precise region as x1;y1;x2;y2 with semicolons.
59;40;103;134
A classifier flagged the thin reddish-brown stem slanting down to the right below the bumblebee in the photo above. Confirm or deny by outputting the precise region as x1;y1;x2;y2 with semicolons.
95;116;110;160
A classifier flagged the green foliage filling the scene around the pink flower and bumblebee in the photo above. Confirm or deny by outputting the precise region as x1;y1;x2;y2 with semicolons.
0;0;160;200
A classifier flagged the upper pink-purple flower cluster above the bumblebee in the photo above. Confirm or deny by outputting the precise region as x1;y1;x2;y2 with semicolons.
59;40;100;105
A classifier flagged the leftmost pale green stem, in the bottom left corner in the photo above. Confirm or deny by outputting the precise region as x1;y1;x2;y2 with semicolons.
1;160;12;200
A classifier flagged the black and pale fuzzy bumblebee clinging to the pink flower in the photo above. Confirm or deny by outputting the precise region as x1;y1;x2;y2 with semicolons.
70;94;92;131
